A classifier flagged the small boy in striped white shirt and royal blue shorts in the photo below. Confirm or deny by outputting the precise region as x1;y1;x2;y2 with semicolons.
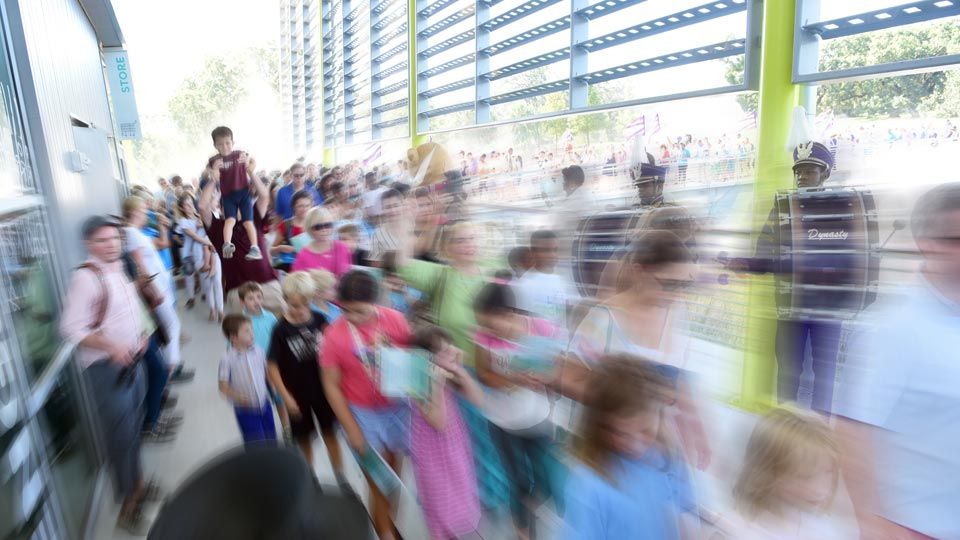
220;314;277;444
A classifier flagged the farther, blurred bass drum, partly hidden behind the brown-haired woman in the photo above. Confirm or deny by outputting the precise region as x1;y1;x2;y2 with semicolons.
571;209;645;298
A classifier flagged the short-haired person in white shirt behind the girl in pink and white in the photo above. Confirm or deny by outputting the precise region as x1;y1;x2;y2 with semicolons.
514;230;578;328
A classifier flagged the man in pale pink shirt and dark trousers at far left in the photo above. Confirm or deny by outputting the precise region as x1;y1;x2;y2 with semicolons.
60;216;158;535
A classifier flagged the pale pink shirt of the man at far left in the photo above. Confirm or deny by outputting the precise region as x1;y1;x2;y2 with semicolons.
60;257;144;369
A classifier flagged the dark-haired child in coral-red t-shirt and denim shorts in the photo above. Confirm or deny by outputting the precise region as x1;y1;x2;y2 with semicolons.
321;270;411;539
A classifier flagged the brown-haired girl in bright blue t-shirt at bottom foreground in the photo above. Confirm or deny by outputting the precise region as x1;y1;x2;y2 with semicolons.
561;355;697;540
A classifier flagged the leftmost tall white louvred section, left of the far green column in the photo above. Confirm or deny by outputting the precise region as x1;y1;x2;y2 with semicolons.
280;0;323;154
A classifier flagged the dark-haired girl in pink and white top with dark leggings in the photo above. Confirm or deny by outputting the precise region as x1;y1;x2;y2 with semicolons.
474;283;562;539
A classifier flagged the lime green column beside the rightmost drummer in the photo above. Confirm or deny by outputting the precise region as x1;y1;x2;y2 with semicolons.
740;0;800;410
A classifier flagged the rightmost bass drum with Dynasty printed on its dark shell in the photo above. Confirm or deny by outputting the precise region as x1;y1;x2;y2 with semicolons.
776;188;880;319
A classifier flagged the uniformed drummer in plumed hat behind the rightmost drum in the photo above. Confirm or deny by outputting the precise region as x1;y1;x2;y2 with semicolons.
728;141;841;414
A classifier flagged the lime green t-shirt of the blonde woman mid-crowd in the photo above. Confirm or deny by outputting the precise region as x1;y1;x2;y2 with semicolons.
399;261;485;367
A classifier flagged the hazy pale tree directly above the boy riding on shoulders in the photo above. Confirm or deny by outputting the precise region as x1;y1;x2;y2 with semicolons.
168;56;247;141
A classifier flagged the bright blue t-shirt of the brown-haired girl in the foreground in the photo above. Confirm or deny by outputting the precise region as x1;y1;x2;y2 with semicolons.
561;450;695;540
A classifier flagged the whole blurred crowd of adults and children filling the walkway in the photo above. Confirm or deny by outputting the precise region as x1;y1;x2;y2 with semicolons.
62;123;960;540
